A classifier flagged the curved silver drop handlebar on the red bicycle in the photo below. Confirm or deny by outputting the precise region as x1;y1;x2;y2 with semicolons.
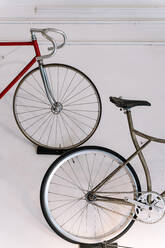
30;28;67;60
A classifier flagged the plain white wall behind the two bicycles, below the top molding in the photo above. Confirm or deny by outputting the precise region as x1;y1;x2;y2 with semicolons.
0;0;165;248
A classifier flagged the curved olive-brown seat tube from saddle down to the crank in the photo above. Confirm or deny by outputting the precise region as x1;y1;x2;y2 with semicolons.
126;110;152;191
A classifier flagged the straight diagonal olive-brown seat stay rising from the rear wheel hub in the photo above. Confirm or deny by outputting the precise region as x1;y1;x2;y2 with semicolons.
91;140;151;194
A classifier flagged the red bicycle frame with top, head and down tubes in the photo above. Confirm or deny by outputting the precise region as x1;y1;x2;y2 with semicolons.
0;40;41;99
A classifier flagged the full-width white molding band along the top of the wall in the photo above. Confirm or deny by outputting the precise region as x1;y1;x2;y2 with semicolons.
0;5;165;23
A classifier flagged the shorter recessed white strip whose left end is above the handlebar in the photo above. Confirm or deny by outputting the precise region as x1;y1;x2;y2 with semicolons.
35;6;165;21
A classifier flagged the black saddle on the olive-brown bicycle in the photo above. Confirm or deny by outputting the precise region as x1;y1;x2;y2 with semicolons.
110;96;151;109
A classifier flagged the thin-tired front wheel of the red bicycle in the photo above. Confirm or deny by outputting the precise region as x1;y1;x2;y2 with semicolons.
13;64;102;150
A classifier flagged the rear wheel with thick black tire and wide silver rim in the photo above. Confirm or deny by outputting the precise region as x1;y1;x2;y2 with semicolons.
40;146;141;244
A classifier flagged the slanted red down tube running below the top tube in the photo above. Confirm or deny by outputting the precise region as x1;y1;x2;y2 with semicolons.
0;57;36;99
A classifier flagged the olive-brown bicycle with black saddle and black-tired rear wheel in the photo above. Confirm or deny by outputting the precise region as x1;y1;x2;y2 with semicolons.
40;97;165;245
